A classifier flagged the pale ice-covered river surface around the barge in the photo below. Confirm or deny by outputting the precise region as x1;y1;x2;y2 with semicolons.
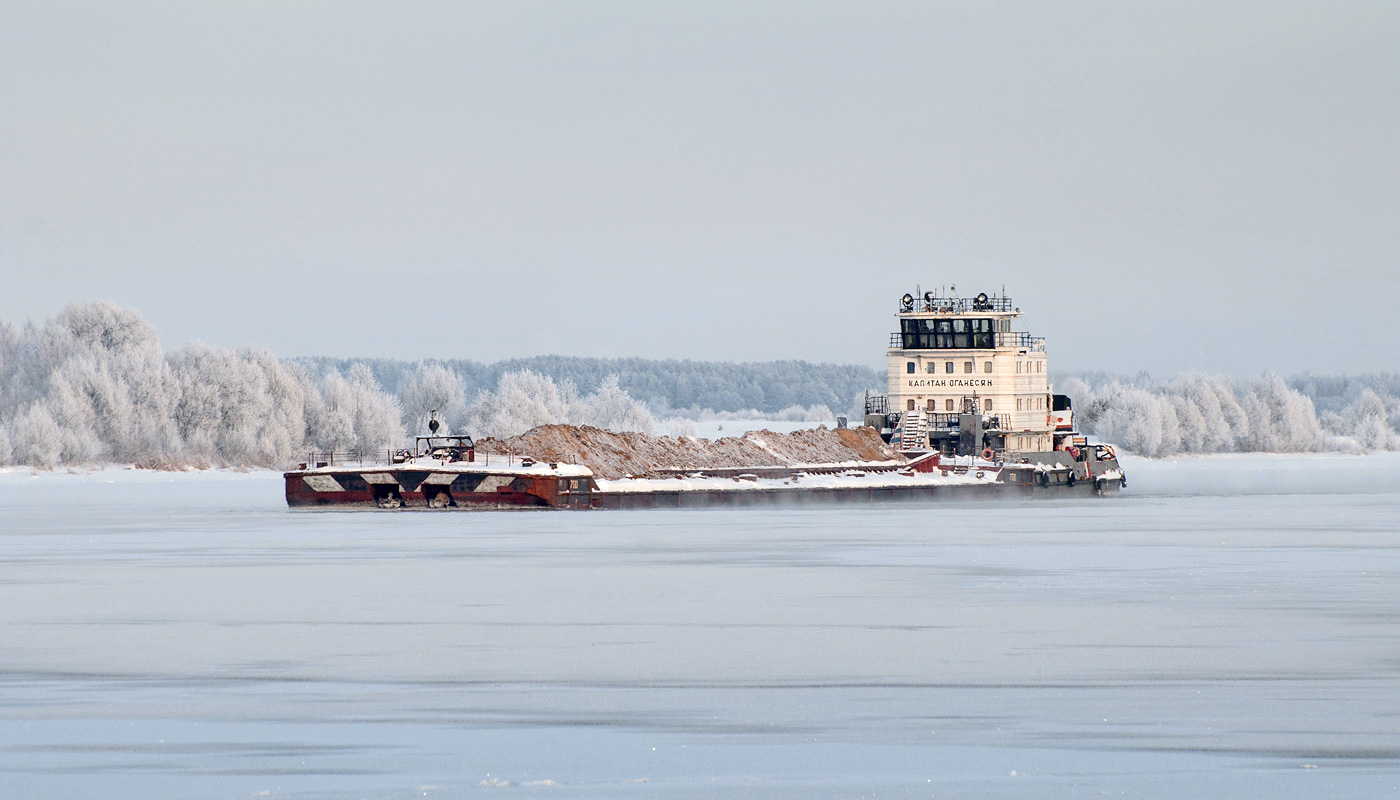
0;455;1400;799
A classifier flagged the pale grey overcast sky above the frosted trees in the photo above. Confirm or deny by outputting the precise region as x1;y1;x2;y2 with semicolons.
0;0;1400;375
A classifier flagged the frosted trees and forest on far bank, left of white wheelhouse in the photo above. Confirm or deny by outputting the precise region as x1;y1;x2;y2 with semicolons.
0;303;872;468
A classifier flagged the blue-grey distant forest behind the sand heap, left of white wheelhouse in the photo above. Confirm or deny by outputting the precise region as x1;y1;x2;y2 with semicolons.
293;356;885;416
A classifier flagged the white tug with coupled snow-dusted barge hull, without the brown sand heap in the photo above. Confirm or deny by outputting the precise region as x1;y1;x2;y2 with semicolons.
284;291;1126;509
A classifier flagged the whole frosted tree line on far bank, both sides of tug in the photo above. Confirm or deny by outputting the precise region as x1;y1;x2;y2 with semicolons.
0;303;1400;468
